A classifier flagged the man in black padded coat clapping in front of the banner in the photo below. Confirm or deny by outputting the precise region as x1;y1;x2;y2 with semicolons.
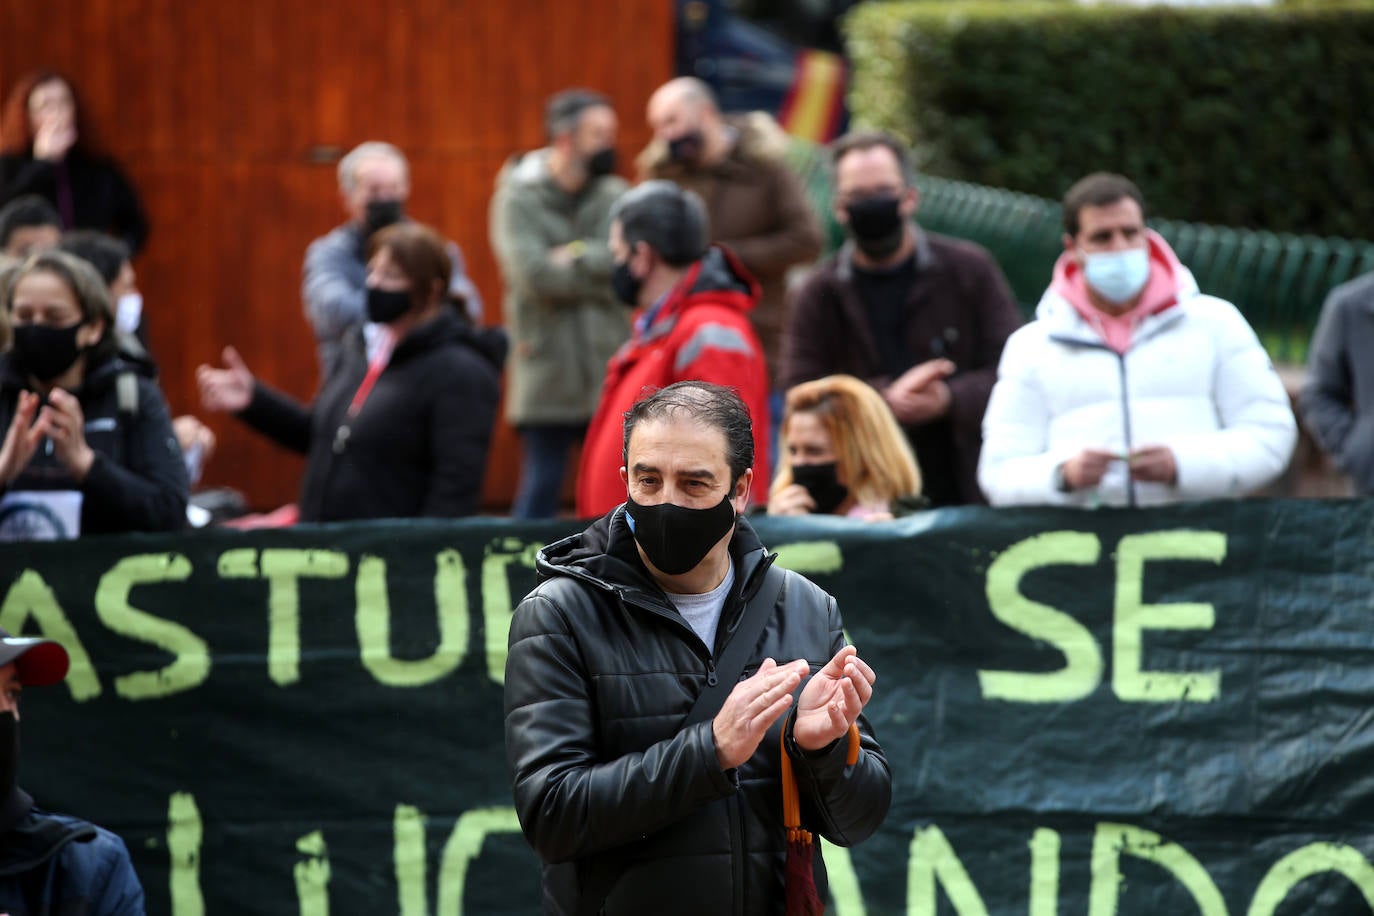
506;382;892;915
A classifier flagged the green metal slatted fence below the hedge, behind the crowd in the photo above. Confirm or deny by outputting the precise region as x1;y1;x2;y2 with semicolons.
791;143;1374;363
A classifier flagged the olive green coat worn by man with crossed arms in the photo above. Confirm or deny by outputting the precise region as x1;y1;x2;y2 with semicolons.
491;150;631;426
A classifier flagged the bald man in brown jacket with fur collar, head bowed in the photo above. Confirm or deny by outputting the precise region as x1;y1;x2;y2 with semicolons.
639;77;820;407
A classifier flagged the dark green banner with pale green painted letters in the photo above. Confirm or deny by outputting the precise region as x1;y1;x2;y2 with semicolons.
0;501;1374;916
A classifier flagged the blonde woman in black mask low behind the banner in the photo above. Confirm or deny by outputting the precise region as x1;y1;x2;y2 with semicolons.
768;375;926;522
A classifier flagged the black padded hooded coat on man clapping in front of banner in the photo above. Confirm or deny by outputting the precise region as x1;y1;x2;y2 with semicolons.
506;507;892;916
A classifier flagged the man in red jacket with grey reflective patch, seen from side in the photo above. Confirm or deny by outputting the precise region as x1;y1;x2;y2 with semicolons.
577;181;769;518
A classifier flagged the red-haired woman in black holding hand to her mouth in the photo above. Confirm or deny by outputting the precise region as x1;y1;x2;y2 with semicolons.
0;70;148;254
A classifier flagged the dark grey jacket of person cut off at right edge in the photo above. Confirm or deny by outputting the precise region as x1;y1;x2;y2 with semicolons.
1300;273;1374;496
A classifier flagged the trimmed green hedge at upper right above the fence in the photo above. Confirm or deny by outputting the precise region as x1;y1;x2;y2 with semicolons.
845;1;1374;238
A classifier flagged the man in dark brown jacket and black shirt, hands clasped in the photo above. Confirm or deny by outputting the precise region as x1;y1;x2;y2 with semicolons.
780;132;1021;507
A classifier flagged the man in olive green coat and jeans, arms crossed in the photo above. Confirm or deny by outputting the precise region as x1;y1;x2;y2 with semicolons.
491;89;629;518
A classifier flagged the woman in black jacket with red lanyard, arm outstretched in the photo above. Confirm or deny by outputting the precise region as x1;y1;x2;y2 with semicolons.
196;222;506;522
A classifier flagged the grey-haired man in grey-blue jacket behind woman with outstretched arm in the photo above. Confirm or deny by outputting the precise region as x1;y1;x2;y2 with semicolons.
301;140;482;378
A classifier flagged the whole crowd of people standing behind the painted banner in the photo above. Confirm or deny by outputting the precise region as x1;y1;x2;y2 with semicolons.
0;73;1374;537
